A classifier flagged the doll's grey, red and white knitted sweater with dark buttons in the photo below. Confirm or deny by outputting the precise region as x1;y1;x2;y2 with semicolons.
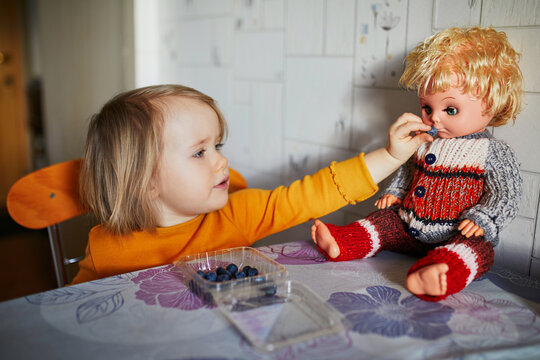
385;130;522;246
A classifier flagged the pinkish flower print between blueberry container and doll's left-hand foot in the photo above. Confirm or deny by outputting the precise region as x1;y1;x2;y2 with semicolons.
258;241;326;265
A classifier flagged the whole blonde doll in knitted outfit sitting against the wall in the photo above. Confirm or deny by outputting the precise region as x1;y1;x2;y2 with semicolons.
311;27;523;301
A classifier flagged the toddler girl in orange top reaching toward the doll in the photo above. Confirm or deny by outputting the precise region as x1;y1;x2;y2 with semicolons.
73;85;433;283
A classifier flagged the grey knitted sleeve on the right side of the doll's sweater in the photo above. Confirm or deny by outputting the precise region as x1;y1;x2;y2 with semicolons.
460;139;523;246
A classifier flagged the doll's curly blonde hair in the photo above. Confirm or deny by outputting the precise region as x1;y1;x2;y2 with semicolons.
399;27;523;126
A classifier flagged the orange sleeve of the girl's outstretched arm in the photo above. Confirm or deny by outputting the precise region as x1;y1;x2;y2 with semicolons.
223;154;378;243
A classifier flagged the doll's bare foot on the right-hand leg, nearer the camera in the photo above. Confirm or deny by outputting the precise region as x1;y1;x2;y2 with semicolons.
405;263;448;296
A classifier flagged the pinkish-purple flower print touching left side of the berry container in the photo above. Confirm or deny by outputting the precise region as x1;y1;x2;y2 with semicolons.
131;265;206;310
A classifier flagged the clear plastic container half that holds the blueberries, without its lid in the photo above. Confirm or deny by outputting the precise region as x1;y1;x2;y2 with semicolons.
175;247;288;303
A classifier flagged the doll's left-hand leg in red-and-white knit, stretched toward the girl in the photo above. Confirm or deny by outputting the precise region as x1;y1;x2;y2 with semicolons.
311;209;418;261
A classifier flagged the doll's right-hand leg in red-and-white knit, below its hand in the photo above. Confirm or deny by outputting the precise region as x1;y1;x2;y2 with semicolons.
406;234;495;301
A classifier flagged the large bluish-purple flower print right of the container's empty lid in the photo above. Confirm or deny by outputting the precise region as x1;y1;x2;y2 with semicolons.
328;286;454;340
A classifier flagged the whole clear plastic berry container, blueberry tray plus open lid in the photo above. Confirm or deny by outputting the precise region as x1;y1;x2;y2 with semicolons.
175;247;343;352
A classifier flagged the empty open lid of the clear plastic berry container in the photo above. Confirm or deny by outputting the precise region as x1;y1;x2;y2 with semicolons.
218;280;344;351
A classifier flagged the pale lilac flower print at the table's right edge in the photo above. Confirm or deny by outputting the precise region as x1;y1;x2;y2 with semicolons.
445;291;540;345
